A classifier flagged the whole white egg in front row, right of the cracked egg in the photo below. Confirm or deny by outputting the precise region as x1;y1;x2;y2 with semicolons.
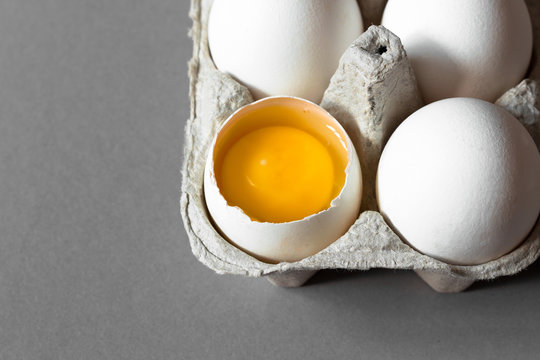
377;98;540;265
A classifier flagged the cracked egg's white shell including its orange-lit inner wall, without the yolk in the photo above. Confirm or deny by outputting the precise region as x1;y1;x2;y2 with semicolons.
204;97;362;263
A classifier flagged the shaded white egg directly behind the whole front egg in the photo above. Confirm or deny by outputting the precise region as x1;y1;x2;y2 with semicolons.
382;0;533;103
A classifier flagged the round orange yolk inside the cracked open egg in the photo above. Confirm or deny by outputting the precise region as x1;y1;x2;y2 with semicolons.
217;126;336;223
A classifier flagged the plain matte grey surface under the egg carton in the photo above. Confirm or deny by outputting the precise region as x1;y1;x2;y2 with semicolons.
0;0;540;360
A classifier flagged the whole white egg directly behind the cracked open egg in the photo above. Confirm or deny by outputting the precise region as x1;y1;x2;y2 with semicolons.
208;0;363;103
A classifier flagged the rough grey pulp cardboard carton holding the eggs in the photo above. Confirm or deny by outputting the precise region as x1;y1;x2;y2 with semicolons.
180;0;540;292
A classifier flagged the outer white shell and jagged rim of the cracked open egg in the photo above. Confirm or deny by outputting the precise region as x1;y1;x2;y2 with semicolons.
204;96;362;263
